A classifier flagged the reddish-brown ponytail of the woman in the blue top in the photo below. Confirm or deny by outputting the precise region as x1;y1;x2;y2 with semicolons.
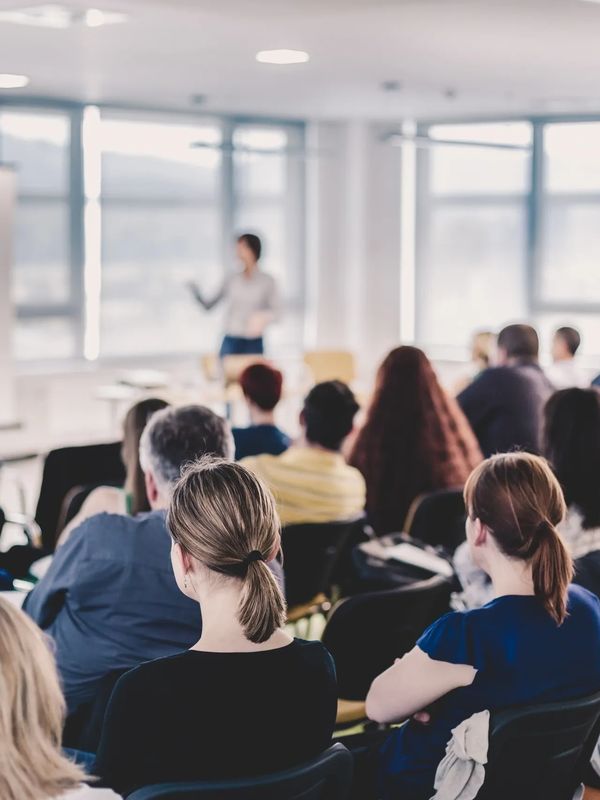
531;520;574;625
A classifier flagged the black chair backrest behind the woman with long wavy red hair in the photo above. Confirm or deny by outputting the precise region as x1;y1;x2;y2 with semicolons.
404;489;466;553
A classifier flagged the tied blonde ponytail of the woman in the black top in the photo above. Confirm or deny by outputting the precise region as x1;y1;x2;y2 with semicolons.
239;561;285;643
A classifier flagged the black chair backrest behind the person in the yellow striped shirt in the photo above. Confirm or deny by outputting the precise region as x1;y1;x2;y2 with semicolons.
281;518;365;606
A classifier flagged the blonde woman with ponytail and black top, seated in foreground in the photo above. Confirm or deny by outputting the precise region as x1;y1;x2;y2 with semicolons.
94;458;337;794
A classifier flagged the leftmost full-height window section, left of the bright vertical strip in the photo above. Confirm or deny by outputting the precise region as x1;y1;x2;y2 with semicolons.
0;108;78;358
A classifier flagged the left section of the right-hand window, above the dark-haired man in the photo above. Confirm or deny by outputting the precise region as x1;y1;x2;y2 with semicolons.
417;123;531;355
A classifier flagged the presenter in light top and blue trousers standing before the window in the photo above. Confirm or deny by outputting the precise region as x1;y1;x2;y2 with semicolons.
189;233;280;358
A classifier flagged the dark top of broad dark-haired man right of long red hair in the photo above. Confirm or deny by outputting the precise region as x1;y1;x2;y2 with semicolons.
457;363;554;458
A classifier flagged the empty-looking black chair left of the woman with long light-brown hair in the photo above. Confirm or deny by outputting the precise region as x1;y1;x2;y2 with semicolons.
35;442;125;550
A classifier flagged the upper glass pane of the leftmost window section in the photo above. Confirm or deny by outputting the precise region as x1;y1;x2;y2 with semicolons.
0;111;70;195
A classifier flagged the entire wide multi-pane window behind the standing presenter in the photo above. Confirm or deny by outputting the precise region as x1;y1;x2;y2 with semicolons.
0;105;304;359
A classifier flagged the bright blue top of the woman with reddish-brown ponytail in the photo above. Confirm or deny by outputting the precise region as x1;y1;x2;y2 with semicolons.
380;586;600;800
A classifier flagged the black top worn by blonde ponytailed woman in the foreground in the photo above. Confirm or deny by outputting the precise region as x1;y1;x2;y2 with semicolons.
92;639;337;795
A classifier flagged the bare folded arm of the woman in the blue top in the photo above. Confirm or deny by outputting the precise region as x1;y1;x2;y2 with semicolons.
367;647;477;723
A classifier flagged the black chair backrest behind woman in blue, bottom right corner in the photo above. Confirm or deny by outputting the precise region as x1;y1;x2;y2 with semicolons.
477;693;600;800
